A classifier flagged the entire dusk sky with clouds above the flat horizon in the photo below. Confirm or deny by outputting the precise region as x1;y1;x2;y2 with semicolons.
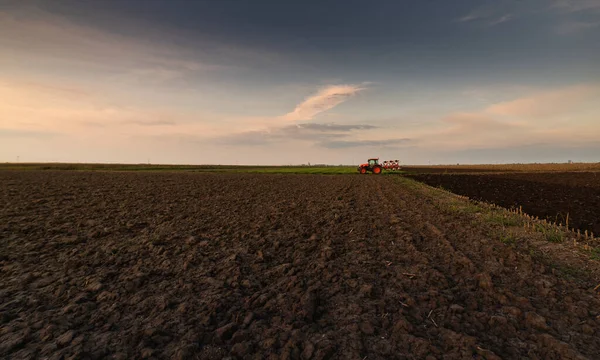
0;0;600;165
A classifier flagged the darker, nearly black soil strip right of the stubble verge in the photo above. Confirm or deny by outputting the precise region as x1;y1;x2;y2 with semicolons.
409;172;600;235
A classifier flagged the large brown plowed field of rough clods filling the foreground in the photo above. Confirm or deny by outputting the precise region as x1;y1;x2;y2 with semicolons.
0;171;600;359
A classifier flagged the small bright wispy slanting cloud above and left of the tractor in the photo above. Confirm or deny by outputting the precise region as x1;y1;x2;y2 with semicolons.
281;84;365;121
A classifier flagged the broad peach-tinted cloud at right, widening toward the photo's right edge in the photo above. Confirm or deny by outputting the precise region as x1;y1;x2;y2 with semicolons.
420;84;600;150
